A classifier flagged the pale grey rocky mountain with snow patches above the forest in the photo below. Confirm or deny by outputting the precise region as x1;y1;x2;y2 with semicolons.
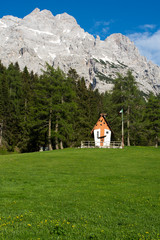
0;8;160;94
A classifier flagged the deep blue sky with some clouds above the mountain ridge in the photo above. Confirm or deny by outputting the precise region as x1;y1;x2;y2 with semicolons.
0;0;160;66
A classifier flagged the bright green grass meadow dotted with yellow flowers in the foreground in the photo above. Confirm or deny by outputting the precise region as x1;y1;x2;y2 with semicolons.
0;147;160;240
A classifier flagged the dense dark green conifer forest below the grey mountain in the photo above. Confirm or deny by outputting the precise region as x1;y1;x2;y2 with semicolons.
0;62;160;152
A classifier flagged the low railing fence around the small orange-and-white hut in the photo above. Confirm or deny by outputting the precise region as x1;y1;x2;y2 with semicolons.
81;141;122;148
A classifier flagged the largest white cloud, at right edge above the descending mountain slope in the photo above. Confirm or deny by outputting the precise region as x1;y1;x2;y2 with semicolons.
128;30;160;66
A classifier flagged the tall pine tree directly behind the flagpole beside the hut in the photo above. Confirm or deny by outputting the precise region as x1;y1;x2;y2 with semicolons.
108;71;142;146
